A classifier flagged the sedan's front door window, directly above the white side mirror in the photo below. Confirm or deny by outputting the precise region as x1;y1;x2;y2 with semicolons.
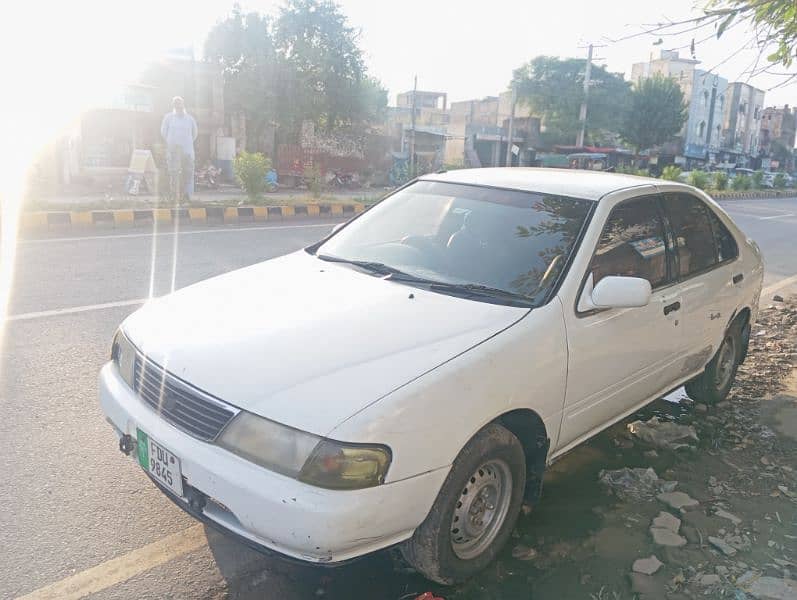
590;196;668;288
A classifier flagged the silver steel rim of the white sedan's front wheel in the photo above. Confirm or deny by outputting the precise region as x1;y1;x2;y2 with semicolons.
450;459;512;560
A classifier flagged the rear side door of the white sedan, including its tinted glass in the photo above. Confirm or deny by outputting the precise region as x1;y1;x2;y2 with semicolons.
664;192;744;377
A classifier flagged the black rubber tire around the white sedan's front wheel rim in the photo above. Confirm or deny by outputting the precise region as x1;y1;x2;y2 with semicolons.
400;423;526;585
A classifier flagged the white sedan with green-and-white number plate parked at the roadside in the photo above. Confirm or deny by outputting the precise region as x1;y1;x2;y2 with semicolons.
100;168;763;583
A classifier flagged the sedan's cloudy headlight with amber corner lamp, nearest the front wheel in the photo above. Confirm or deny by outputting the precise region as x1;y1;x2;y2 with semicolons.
216;412;390;490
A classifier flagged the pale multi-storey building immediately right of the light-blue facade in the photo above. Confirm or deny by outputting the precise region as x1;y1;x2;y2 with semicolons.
723;81;764;167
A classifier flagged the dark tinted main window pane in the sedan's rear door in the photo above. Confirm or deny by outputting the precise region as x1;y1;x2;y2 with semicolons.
664;194;717;277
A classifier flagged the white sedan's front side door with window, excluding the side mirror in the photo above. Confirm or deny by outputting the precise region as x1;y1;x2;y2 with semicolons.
558;193;682;449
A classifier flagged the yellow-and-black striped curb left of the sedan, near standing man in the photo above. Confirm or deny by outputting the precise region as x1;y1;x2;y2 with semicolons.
20;203;365;231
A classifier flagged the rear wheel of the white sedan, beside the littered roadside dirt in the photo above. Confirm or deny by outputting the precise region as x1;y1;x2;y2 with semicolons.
685;322;749;404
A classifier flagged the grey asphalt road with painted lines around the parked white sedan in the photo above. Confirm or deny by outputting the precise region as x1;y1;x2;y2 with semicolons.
0;198;797;600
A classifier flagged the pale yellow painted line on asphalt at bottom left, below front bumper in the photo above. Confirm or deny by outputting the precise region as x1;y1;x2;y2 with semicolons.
17;524;207;600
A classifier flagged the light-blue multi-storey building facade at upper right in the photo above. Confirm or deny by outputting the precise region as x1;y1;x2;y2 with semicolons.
682;69;728;166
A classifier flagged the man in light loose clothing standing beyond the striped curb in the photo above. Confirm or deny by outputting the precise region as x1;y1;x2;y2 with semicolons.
161;96;197;202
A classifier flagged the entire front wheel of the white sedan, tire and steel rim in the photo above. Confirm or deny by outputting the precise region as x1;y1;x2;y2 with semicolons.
401;423;526;585
